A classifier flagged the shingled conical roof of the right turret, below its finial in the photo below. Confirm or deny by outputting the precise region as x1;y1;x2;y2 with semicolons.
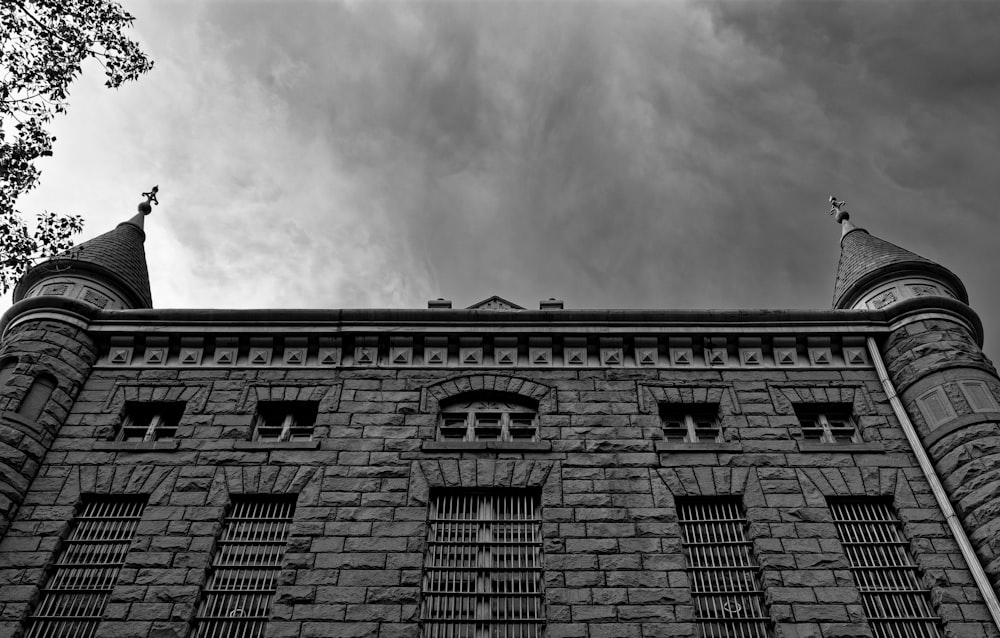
833;229;969;308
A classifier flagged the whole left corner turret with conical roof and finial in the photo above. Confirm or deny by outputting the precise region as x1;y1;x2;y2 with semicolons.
0;188;156;537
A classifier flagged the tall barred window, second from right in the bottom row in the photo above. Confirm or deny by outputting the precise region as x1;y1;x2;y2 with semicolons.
677;499;771;638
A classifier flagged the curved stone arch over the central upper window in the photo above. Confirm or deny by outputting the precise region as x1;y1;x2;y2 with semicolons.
420;374;556;414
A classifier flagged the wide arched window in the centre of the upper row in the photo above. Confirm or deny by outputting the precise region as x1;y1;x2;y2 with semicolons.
438;394;538;441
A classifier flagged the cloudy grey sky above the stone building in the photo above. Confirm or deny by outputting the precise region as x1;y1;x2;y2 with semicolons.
2;0;1000;359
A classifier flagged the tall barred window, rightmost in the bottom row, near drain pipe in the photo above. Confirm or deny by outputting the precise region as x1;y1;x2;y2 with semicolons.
830;499;941;638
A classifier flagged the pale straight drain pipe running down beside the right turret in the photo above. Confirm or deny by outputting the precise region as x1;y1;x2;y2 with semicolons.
867;337;1000;629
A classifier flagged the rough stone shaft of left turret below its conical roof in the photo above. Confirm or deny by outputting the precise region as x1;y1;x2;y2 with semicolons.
0;320;97;537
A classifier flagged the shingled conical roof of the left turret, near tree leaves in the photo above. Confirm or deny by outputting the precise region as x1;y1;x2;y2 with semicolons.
14;213;153;308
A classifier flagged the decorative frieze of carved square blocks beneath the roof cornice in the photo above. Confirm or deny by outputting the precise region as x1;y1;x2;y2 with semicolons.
99;333;871;370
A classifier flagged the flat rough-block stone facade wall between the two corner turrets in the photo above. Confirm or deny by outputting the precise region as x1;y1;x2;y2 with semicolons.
0;369;997;638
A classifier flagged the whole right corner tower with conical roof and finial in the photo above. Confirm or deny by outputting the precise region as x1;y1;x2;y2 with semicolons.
830;197;1000;590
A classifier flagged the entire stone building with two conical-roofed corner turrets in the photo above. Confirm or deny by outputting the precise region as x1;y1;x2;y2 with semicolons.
0;196;1000;638
